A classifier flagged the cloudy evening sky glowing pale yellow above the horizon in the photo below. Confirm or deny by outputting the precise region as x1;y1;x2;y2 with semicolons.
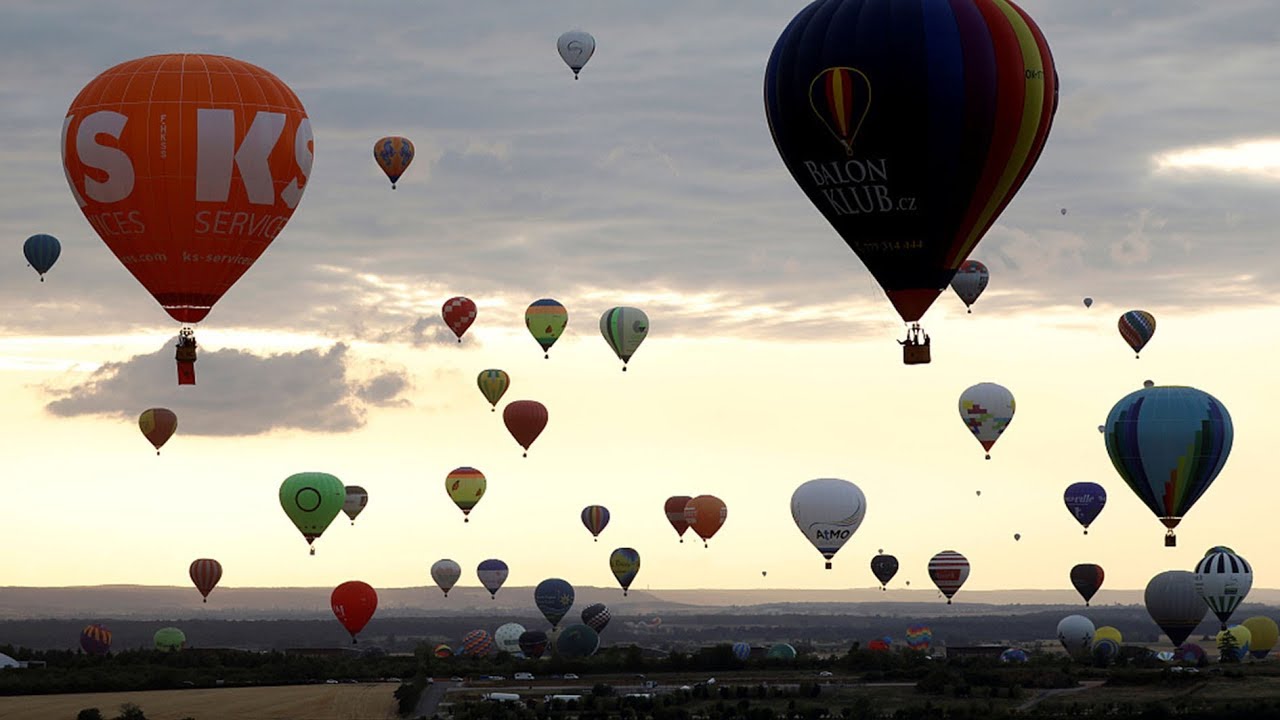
0;0;1280;602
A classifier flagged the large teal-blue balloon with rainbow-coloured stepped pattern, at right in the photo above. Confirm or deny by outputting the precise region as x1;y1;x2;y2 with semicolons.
1103;386;1234;547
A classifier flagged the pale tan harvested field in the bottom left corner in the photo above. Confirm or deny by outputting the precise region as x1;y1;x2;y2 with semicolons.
0;683;397;720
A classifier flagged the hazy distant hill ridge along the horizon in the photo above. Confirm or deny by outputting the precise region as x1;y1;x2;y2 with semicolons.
0;585;1280;620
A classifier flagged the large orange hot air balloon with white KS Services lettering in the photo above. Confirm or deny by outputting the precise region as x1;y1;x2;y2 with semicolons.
63;54;314;384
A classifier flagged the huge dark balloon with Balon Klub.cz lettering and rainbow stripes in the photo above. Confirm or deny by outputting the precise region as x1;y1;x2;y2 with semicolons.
764;0;1057;364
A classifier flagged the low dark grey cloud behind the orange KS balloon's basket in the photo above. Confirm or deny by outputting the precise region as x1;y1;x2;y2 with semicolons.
45;343;410;436
